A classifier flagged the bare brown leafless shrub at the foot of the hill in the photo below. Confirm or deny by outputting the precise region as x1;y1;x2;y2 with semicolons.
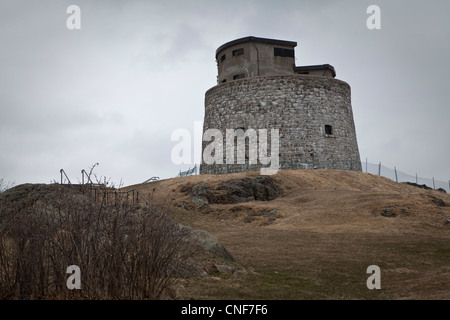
0;184;195;299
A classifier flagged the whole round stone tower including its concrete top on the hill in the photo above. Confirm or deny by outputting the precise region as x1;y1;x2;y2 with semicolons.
200;37;361;174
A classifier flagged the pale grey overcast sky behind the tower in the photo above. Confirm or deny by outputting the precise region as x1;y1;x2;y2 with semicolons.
0;0;450;185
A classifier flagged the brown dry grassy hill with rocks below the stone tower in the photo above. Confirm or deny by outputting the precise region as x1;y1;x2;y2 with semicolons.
123;170;450;299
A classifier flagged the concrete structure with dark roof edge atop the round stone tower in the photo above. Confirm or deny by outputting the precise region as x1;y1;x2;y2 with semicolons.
216;36;336;84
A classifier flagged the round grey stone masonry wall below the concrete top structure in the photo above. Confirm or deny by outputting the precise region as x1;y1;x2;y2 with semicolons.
200;75;361;174
